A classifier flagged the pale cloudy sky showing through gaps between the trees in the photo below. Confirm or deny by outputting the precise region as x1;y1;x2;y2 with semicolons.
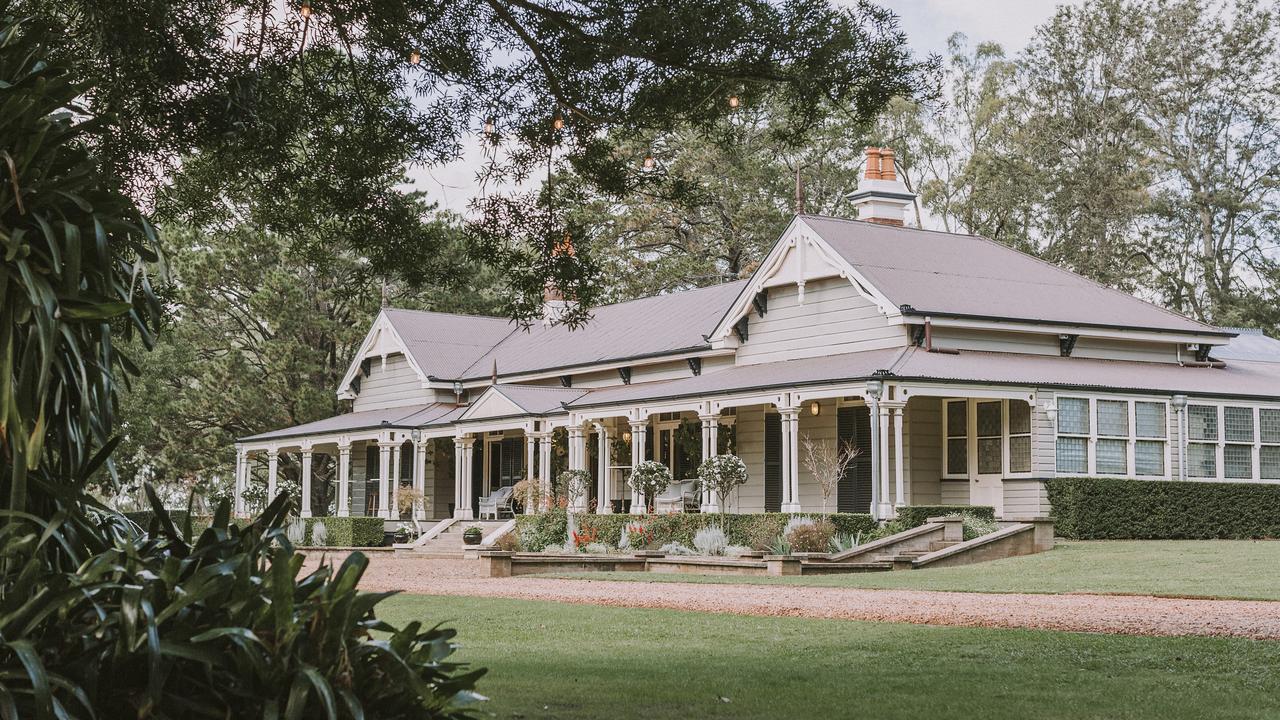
408;0;1078;213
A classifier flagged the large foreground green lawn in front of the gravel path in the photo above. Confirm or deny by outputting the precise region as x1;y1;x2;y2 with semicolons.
379;596;1280;720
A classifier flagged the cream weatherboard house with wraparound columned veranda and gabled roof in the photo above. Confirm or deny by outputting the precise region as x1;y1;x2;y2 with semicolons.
236;149;1280;521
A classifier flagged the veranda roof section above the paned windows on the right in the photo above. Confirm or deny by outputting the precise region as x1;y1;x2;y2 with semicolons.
891;347;1280;398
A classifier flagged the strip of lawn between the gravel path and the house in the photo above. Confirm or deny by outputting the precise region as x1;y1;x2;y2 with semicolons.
537;541;1280;600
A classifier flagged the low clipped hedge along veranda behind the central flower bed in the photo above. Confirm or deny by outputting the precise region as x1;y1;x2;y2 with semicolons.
516;510;877;552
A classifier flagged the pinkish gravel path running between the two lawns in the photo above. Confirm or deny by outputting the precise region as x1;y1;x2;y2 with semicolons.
307;555;1280;639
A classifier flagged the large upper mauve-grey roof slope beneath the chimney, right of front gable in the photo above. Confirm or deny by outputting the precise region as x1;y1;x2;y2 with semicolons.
801;215;1222;333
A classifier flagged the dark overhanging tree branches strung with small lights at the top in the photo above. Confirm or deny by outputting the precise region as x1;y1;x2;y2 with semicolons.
7;0;920;320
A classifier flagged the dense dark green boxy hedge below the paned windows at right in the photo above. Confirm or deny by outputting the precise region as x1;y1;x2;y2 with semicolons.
1044;478;1280;539
